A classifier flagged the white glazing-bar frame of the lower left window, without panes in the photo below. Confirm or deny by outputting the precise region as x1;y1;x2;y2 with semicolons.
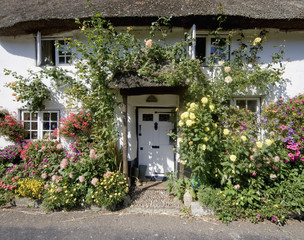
20;110;60;140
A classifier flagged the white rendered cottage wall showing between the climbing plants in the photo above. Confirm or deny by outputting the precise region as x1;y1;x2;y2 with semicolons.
0;28;304;149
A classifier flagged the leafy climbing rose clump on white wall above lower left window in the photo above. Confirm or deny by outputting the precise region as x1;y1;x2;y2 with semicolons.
4;69;51;111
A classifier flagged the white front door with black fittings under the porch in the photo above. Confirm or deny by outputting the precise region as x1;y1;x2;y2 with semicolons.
138;108;174;177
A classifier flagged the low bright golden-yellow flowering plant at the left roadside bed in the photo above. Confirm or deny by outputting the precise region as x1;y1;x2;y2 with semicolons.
16;178;44;199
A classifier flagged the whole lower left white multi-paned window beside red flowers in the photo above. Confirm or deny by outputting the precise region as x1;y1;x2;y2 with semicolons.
21;111;59;139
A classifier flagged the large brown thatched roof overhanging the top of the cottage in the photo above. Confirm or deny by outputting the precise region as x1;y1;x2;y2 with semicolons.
0;0;304;35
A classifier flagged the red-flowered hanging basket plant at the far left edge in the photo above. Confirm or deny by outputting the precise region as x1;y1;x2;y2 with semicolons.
0;110;24;142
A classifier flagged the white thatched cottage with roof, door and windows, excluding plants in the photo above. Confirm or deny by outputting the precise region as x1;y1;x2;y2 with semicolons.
0;0;304;177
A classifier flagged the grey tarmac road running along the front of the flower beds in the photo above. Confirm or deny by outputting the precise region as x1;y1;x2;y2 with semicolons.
0;208;304;240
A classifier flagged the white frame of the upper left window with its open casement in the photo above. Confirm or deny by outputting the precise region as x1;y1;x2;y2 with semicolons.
36;32;72;67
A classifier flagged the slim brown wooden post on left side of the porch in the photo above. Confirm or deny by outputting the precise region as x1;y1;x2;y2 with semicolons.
122;94;129;178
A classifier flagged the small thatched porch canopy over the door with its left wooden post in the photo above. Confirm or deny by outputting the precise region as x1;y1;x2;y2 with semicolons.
108;72;186;176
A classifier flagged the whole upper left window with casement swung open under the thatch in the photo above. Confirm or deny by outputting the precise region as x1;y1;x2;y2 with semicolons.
37;33;72;66
